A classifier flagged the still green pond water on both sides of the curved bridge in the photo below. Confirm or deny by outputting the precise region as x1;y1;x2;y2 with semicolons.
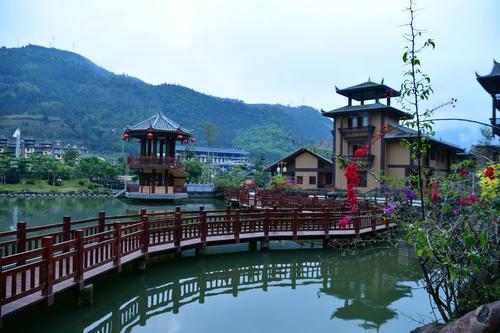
0;199;432;333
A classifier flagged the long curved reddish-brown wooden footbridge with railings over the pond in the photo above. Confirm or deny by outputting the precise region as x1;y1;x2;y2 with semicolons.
0;198;396;326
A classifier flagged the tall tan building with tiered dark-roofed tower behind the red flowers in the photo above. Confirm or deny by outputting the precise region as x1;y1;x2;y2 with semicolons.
322;81;463;192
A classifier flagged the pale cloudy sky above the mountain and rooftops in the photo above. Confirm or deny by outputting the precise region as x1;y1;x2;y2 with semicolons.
0;0;500;147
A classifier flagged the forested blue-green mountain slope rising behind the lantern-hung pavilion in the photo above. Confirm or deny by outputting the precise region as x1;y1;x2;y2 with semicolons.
0;45;331;158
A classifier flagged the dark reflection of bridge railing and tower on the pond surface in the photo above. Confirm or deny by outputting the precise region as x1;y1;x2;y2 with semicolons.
69;244;421;333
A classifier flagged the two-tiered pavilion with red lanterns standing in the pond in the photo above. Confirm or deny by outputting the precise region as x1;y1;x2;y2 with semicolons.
122;113;192;200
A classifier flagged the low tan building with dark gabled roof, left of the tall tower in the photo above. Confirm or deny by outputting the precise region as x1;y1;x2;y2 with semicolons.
264;147;333;189
